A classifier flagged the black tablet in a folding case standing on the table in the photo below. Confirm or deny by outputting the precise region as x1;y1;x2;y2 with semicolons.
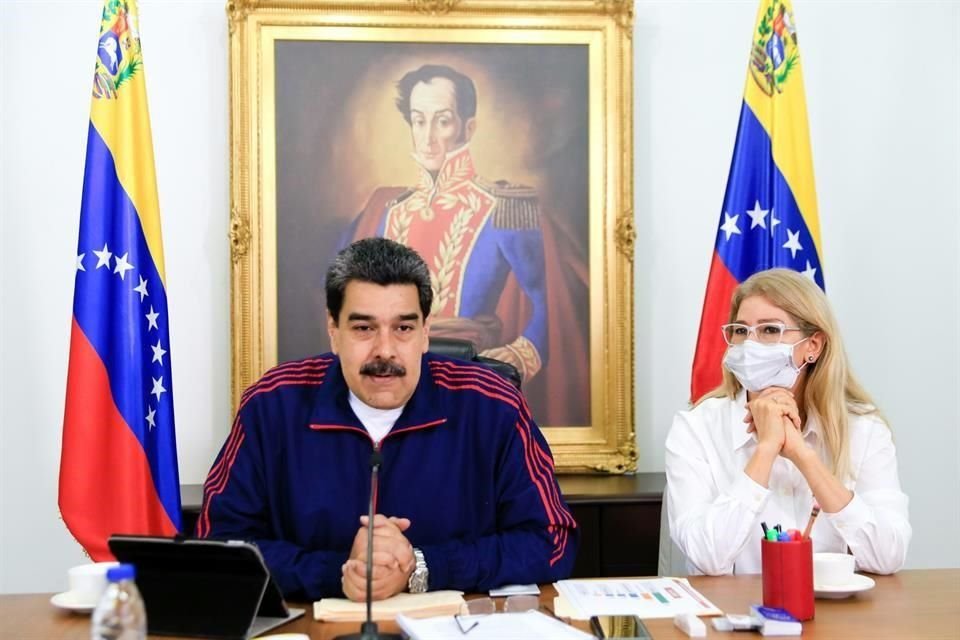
109;535;304;640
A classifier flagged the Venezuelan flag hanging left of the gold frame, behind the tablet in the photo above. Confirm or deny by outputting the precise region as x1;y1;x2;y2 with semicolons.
59;0;180;561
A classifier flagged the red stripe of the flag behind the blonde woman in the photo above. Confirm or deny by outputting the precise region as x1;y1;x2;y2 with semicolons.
690;251;739;402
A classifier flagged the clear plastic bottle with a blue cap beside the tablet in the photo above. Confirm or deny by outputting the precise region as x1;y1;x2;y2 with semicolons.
90;564;147;640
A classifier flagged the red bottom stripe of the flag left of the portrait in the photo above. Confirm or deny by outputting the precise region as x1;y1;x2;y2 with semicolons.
59;320;177;562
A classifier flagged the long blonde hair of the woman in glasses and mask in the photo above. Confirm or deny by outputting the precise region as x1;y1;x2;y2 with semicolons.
698;269;886;480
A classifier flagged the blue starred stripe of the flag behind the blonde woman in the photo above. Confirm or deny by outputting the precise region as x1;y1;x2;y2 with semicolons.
716;102;823;289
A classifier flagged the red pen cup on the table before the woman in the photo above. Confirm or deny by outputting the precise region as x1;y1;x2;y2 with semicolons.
760;538;813;620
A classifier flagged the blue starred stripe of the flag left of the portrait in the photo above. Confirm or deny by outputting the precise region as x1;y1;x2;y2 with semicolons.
73;124;180;523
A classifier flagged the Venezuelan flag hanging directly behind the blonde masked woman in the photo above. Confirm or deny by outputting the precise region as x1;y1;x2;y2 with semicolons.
690;0;824;400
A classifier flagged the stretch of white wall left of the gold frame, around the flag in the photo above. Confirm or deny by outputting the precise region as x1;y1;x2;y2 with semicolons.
0;0;231;592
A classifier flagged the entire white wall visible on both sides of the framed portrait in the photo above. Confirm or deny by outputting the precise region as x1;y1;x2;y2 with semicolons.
0;0;960;592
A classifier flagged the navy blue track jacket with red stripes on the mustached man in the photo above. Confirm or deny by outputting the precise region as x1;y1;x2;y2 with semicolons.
197;354;579;599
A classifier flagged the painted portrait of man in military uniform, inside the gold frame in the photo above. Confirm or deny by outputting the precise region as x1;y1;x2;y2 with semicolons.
276;42;590;426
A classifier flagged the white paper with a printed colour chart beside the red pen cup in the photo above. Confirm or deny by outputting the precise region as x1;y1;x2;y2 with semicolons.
556;578;723;620
